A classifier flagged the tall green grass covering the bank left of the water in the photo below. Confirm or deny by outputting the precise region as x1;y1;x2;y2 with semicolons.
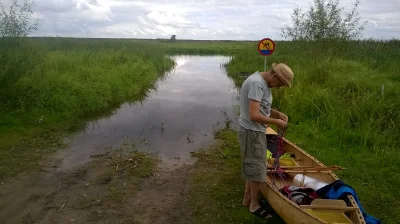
0;40;174;178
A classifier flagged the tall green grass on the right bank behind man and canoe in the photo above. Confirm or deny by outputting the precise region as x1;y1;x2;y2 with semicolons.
226;41;400;223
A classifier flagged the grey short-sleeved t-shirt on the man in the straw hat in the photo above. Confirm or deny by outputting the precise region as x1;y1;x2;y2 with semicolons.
239;71;272;133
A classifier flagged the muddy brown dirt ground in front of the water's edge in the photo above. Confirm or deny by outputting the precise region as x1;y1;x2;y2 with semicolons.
0;150;192;224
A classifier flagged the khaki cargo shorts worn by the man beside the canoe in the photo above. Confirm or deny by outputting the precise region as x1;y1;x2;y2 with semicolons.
238;125;267;182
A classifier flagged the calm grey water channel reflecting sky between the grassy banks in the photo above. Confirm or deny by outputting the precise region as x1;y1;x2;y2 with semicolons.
54;56;239;170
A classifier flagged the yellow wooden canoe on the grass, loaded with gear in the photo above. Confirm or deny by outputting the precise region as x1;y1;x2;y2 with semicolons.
260;127;365;224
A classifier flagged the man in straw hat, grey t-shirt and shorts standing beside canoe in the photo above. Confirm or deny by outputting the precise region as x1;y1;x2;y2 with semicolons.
238;63;294;219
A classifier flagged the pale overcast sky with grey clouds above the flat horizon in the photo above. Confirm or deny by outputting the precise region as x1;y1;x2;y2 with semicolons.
0;0;400;40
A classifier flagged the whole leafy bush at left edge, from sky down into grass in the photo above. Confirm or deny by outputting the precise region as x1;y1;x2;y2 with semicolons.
0;0;43;89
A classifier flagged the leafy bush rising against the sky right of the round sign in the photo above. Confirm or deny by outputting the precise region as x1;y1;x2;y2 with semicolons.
281;0;366;40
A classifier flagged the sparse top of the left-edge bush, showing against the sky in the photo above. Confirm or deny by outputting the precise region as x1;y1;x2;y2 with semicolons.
0;0;39;37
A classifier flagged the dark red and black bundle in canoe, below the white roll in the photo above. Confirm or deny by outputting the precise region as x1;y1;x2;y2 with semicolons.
279;185;318;205
